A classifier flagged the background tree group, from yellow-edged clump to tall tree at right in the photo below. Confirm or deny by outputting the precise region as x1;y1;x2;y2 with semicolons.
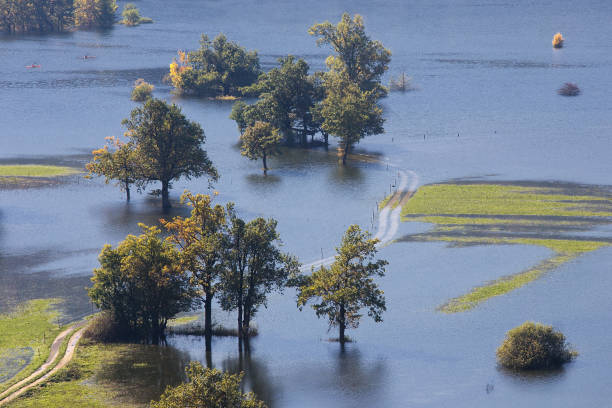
169;13;391;167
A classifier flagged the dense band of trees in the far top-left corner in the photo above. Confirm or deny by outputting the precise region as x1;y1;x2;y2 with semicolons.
0;0;117;33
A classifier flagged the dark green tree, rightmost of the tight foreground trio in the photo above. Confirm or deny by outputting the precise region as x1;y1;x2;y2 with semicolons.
221;214;299;339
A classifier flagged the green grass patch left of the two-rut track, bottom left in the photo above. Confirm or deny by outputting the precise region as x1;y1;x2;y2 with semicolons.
0;299;61;392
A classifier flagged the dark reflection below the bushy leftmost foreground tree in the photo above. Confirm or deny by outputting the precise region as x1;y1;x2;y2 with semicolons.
96;345;189;404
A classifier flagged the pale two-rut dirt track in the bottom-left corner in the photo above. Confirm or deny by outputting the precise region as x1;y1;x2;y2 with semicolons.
0;321;87;406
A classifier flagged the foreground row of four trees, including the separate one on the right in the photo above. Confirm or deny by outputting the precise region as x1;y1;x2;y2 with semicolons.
89;199;387;351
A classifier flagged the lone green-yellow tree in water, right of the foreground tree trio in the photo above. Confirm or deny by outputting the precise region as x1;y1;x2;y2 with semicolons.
297;225;387;344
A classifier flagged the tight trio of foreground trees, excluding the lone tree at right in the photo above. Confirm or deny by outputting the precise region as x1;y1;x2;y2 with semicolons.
89;192;299;348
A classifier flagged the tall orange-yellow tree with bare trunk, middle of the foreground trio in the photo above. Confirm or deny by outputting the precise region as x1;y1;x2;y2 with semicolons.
161;191;233;348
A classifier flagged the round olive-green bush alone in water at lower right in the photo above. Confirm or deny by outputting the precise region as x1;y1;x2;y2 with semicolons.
497;322;578;370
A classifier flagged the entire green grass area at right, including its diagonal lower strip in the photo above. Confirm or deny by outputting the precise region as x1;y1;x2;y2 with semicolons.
402;183;612;313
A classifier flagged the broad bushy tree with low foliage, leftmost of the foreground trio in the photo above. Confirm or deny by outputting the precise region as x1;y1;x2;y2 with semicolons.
89;224;194;343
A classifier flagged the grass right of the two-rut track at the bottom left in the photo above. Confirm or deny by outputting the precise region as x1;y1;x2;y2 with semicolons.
8;340;131;408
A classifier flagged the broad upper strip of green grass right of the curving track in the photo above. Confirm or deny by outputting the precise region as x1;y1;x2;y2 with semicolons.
402;184;612;219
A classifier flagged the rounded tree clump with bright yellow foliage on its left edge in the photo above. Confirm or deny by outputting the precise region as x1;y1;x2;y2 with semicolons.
169;34;261;96
